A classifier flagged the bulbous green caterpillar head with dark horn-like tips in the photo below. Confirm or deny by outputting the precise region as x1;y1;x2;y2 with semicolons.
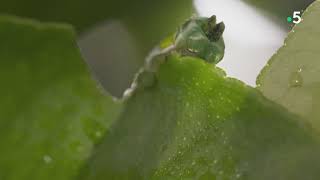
174;16;225;64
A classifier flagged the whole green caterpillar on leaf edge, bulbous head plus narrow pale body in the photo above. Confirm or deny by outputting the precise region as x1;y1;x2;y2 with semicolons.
146;16;225;71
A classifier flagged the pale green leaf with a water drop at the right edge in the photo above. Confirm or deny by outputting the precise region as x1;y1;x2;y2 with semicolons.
257;1;320;130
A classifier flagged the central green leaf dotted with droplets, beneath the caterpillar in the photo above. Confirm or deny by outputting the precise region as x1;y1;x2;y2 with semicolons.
79;55;320;180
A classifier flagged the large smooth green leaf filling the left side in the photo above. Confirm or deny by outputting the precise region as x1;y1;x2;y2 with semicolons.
0;16;120;180
